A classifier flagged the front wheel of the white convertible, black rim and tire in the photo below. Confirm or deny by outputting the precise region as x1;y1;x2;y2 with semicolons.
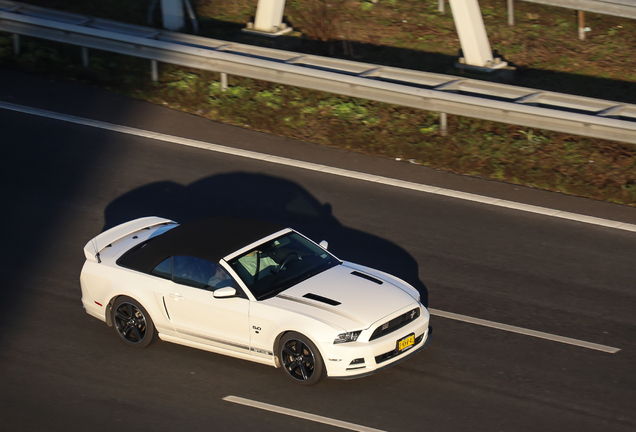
278;332;325;386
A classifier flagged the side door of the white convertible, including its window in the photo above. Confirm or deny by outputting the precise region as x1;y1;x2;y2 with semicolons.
158;256;250;352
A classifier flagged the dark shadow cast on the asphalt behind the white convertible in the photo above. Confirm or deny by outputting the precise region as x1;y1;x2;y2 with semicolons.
104;172;428;306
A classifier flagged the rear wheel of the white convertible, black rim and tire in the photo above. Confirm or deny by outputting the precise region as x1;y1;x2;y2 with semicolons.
111;296;156;348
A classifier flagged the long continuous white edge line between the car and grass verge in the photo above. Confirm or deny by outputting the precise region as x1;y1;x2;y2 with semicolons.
0;102;636;232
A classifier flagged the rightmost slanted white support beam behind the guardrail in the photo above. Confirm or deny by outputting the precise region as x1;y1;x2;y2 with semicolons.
450;0;507;71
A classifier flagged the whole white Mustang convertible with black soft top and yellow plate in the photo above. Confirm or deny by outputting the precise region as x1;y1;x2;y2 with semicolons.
80;217;432;385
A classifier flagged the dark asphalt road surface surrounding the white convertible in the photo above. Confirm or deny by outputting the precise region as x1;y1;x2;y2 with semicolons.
0;70;636;432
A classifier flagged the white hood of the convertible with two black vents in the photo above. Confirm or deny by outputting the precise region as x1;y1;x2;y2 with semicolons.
268;264;418;330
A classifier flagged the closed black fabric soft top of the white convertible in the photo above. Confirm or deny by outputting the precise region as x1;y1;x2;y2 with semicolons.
117;216;285;273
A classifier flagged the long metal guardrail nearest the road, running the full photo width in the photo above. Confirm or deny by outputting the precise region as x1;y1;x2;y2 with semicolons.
0;0;636;144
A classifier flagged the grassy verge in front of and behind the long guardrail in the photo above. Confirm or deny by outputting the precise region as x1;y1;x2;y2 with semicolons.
0;0;636;206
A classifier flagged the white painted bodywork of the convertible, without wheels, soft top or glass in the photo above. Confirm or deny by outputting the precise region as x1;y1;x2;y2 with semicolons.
80;217;430;378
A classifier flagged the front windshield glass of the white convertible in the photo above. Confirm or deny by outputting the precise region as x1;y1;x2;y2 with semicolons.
229;232;340;300
